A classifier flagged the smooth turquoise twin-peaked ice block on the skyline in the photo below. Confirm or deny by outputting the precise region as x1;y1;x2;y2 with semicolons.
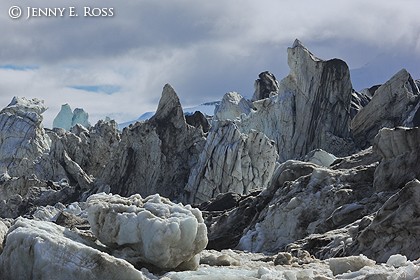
53;103;90;130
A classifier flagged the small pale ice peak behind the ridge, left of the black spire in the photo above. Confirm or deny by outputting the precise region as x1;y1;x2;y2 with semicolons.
214;92;253;121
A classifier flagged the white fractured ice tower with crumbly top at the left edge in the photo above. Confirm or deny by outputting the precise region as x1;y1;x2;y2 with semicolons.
0;97;50;177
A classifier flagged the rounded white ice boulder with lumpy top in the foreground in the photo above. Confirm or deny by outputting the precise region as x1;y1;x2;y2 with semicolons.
87;193;207;270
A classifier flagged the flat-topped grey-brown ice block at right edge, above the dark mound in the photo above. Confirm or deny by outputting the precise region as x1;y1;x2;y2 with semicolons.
373;127;420;192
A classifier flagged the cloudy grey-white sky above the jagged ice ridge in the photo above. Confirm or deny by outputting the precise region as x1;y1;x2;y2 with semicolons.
0;0;420;127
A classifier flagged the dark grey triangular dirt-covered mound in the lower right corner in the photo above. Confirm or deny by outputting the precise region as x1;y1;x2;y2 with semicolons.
347;180;420;262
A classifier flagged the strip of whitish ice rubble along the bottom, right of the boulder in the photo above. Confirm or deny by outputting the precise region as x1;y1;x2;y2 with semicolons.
161;250;420;280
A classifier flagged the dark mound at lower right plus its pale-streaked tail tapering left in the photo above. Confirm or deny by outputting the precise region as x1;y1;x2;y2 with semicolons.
278;180;420;263
